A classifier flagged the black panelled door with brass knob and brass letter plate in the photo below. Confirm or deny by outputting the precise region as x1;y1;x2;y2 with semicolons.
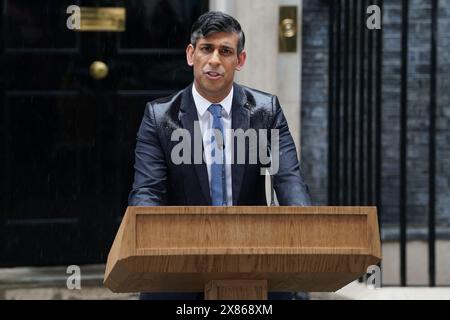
0;0;207;267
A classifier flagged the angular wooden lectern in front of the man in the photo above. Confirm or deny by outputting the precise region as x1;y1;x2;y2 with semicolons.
104;207;381;300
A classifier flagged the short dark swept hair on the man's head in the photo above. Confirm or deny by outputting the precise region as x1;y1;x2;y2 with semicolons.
191;11;245;55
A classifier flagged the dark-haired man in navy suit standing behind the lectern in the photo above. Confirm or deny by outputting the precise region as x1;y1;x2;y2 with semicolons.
129;12;310;299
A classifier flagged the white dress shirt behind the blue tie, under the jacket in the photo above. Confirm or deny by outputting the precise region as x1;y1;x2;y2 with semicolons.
192;83;233;206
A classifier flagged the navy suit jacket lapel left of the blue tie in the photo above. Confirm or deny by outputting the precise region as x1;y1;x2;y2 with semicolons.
180;85;212;203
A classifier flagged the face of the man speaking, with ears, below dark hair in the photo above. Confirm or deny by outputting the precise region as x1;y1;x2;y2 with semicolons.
186;32;246;103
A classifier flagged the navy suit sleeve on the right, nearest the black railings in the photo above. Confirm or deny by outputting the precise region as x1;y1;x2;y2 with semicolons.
271;96;311;206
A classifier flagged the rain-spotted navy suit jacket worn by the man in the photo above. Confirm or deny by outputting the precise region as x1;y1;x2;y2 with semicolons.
128;84;310;206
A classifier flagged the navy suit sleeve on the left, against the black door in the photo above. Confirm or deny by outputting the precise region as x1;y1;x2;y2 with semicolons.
128;103;167;206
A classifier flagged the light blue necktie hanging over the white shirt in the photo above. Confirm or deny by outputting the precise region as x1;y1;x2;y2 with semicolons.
208;104;227;206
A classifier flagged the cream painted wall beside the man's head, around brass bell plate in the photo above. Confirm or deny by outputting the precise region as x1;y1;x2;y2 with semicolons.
210;0;302;152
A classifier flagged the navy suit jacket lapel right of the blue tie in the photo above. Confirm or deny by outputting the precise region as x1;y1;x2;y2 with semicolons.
231;84;250;205
